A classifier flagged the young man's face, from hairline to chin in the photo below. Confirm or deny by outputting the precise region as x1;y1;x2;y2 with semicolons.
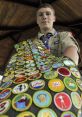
37;7;55;30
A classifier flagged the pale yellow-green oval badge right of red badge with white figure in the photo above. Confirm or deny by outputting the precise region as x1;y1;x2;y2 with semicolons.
71;92;82;109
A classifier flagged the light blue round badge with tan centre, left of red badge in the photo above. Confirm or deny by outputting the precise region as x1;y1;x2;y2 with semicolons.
33;90;52;108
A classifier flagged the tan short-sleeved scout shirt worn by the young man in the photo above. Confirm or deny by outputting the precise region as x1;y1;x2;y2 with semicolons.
49;32;80;56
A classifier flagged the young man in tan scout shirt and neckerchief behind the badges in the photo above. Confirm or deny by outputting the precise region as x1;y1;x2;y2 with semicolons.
37;3;80;65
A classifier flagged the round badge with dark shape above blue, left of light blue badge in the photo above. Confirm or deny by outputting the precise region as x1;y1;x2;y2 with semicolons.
12;93;32;111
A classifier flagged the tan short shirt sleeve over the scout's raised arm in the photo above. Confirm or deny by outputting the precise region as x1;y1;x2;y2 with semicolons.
60;32;80;53
